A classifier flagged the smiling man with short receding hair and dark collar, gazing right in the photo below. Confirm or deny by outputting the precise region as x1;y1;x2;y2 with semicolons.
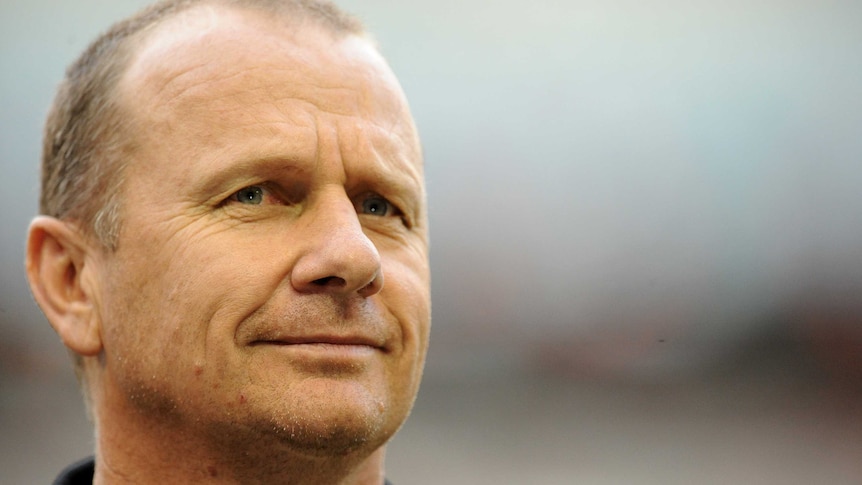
27;0;430;484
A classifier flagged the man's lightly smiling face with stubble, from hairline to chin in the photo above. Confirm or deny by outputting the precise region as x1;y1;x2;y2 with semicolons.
93;6;430;451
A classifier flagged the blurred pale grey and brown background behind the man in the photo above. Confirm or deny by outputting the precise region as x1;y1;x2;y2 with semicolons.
0;0;862;485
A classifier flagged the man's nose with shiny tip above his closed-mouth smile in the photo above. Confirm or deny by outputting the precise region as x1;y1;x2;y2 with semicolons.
290;192;383;298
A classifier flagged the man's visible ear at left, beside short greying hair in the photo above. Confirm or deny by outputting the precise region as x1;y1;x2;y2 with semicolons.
26;216;102;356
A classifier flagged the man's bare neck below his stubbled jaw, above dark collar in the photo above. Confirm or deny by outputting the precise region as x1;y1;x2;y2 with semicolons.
93;380;385;485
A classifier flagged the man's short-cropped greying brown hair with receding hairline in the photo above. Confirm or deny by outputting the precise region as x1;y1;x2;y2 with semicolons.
39;0;364;251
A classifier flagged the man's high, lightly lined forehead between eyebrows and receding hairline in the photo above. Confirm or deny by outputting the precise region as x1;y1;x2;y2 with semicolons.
118;6;421;163
